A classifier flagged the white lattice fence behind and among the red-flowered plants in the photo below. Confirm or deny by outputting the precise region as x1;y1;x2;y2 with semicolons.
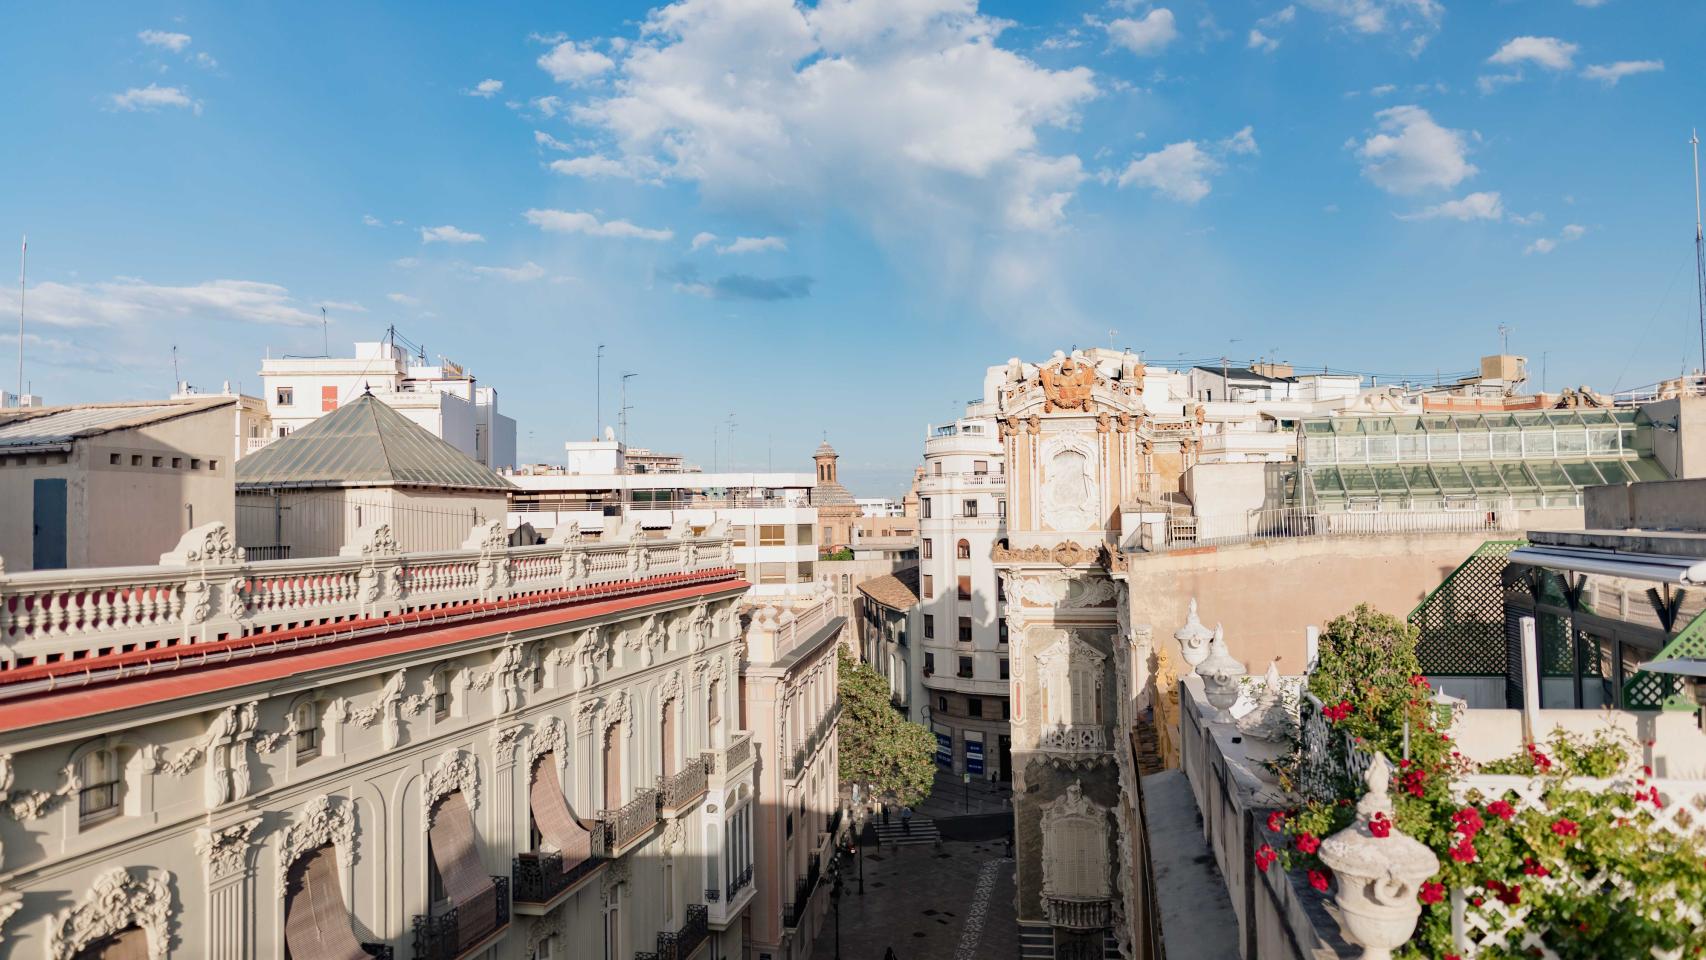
1452;774;1706;960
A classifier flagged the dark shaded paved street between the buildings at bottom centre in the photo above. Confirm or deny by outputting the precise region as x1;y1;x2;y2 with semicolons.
812;841;1018;960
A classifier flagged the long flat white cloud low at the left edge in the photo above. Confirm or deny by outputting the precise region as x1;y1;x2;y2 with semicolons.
0;276;329;327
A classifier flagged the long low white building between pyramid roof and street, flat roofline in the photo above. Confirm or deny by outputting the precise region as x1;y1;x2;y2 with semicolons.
505;433;817;597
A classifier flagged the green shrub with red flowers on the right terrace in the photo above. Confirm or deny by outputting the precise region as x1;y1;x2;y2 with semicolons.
1257;605;1706;960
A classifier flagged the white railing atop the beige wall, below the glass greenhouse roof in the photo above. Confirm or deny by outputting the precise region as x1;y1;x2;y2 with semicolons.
1140;500;1522;551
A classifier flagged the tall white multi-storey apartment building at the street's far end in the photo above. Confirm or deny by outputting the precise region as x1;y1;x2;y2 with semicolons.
909;402;1012;779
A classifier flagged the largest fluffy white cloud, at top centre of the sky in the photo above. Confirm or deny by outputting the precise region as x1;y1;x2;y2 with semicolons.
559;0;1097;235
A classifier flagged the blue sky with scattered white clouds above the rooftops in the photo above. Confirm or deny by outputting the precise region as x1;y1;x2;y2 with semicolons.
0;0;1706;494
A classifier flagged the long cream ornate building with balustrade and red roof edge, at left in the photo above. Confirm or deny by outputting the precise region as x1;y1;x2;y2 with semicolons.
0;520;756;960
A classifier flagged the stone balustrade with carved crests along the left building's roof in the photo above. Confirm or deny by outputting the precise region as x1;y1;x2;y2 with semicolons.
0;523;732;675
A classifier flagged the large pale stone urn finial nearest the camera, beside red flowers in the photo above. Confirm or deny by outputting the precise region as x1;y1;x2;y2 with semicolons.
1320;754;1440;960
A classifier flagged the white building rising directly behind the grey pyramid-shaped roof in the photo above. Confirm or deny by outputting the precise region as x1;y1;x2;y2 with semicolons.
261;339;515;469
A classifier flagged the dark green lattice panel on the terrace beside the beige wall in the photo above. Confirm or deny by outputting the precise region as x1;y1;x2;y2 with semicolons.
1409;541;1527;677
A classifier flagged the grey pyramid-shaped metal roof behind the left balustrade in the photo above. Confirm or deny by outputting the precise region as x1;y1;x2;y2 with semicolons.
237;394;514;491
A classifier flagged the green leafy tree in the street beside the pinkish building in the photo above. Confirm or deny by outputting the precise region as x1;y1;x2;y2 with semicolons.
836;646;937;807
